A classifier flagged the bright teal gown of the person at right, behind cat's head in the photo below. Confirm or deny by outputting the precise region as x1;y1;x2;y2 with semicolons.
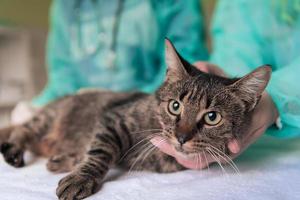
210;0;300;137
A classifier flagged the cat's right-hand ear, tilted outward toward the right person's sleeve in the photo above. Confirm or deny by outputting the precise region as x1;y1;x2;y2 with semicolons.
230;65;272;110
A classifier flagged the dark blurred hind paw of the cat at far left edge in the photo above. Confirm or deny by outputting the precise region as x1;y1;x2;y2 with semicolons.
0;142;25;167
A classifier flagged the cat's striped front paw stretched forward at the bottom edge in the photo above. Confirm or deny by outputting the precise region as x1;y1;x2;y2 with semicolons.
56;173;100;200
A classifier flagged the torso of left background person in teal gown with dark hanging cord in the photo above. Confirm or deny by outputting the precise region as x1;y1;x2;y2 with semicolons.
66;0;161;91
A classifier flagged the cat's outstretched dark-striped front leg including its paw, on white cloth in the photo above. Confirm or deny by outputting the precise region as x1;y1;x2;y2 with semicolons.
56;129;123;200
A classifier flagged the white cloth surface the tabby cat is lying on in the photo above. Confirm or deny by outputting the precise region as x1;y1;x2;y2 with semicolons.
0;137;300;200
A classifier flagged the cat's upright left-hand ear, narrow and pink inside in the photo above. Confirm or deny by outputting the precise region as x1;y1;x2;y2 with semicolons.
165;38;188;82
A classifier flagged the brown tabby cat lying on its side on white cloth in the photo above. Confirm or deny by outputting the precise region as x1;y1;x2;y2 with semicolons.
0;39;271;200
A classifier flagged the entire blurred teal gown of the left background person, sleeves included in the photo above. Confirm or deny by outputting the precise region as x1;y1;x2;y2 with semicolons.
33;0;207;106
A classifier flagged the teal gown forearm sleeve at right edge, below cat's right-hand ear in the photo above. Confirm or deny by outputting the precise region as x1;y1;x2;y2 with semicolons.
267;57;300;137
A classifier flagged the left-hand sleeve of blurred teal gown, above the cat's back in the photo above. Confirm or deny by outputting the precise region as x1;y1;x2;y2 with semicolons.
32;0;78;106
